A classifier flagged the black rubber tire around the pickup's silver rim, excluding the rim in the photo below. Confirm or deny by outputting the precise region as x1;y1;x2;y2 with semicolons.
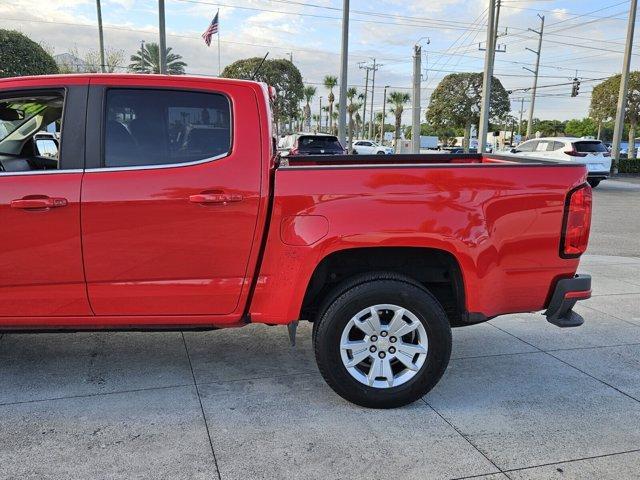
313;273;451;408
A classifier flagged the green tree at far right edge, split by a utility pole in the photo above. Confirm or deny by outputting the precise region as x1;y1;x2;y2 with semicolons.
589;71;640;158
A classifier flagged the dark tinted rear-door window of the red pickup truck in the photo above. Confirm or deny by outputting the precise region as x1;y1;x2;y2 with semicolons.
104;89;231;167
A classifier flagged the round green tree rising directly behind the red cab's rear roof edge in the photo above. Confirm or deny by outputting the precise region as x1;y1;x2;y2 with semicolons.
222;57;304;133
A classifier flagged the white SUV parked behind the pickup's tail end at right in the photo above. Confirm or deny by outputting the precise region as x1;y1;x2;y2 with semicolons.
510;137;611;188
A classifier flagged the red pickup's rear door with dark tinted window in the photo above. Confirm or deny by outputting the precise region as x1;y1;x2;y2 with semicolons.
82;80;262;315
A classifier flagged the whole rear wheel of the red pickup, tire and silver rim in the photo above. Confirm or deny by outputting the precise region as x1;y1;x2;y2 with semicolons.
314;274;451;408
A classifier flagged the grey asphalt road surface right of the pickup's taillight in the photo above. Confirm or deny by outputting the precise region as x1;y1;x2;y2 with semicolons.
587;178;640;257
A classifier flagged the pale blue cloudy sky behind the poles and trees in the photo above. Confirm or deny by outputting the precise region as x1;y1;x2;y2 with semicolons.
0;0;640;123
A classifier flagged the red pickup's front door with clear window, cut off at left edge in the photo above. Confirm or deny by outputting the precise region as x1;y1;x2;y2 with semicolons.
0;85;91;320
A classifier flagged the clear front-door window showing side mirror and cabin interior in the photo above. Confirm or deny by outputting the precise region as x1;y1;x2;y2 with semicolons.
0;91;64;174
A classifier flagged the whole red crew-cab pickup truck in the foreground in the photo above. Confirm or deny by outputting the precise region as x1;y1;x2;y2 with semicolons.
0;75;591;408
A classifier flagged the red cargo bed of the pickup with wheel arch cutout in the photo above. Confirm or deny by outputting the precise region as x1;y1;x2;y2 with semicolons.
252;153;587;323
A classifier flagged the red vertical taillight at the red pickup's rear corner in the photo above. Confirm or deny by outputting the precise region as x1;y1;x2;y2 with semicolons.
560;184;592;258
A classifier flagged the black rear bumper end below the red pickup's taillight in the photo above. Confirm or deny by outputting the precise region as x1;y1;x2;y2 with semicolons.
544;275;591;328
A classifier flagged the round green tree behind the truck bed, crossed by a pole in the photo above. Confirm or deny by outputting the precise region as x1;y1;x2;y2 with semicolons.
427;72;511;152
